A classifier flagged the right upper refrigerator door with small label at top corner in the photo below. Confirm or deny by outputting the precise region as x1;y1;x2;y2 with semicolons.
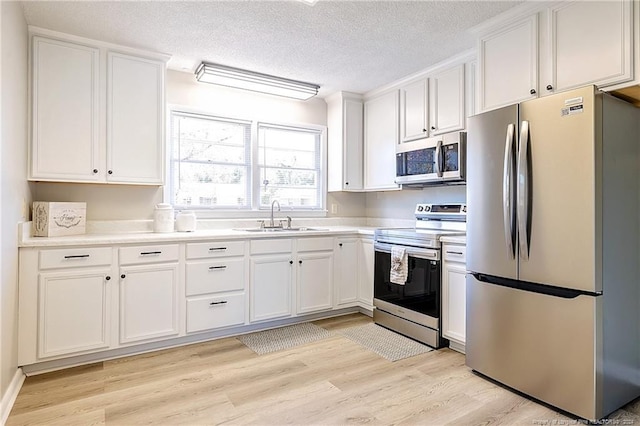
516;86;602;292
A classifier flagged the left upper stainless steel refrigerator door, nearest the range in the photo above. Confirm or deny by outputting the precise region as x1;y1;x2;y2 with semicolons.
467;105;518;279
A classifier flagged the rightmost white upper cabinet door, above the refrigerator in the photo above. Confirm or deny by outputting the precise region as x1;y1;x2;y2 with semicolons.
543;0;633;91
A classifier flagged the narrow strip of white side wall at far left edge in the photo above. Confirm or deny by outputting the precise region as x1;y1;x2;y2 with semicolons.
0;1;31;412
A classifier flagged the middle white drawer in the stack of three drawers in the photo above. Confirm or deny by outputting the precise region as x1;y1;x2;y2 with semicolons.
186;258;245;296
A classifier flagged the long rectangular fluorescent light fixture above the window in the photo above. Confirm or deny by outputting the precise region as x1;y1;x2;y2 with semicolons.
196;62;320;100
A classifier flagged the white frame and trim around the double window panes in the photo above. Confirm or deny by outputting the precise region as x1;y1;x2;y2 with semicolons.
162;104;328;219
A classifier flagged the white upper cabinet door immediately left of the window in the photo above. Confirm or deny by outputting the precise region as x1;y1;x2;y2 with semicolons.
107;52;164;185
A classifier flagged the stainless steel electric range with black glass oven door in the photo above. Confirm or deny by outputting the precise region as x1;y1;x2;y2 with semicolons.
373;203;467;348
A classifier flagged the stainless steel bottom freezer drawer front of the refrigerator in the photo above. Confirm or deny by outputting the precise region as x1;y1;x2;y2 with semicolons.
466;274;602;419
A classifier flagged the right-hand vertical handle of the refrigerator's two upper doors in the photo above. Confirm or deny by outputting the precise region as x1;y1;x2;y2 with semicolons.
517;121;529;260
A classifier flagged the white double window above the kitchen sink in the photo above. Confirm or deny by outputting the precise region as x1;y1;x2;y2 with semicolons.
167;110;324;211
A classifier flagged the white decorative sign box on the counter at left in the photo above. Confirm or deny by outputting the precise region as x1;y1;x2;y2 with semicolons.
33;201;87;237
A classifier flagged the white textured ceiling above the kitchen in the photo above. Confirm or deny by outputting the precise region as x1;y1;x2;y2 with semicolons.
23;0;518;96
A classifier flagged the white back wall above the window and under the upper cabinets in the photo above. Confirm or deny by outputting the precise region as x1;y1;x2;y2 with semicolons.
34;70;365;220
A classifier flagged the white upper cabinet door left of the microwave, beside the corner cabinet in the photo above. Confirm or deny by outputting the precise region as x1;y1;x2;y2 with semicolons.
364;90;398;190
